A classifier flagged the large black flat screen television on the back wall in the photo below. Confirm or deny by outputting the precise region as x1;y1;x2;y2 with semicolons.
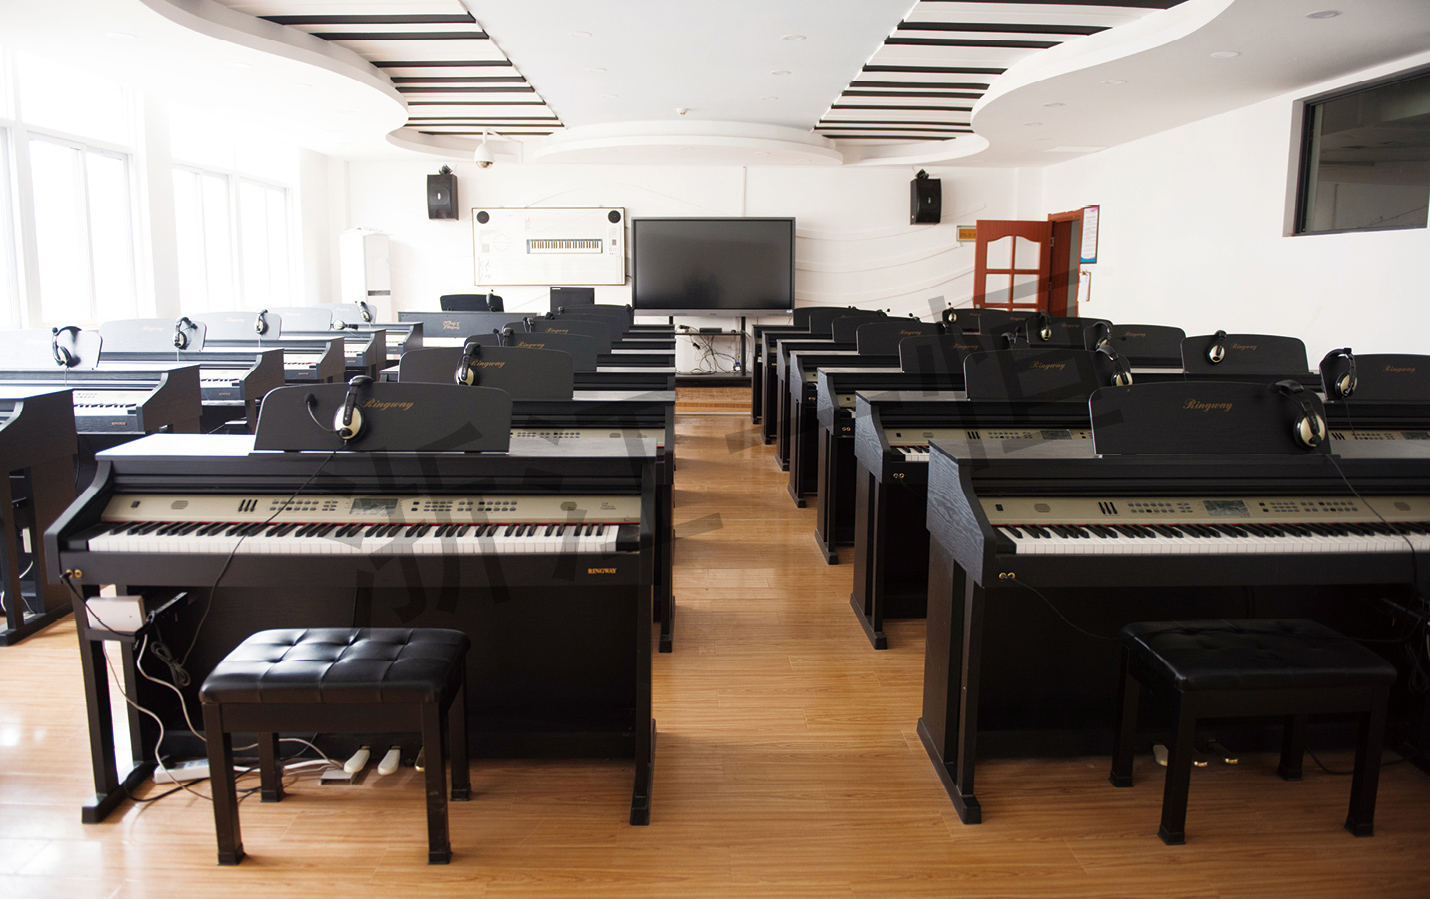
631;219;795;314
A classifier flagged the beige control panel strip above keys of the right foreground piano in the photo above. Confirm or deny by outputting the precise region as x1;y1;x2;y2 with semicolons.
980;496;1430;527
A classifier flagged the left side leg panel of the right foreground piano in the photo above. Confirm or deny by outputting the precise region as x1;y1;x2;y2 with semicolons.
918;540;982;825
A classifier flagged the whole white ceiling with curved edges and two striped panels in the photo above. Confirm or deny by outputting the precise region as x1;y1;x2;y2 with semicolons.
0;0;1430;166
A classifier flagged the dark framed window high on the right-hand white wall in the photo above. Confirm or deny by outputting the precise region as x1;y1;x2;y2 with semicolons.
1296;70;1430;234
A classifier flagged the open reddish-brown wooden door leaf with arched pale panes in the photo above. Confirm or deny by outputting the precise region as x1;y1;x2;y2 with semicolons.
974;219;1052;312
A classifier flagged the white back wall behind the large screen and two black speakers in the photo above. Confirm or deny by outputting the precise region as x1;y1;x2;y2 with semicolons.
329;160;1015;333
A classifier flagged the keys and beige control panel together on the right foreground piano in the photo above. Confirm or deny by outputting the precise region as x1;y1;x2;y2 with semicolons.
980;496;1430;556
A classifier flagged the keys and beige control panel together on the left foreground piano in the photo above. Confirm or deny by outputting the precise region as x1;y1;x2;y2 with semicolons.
86;495;641;556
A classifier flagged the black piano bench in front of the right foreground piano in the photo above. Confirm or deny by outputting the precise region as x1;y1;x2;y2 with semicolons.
1108;619;1396;846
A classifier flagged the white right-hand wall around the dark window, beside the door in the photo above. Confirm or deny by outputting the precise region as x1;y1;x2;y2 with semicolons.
1020;53;1430;357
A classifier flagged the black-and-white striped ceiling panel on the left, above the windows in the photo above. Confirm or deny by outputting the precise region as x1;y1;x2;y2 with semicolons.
220;0;563;137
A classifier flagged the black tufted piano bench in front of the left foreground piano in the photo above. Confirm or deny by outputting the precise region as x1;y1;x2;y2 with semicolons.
199;627;472;865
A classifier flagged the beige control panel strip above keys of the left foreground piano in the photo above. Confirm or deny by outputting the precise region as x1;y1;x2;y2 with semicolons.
100;493;641;525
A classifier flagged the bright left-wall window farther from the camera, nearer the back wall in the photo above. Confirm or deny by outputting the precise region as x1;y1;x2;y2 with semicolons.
174;167;293;312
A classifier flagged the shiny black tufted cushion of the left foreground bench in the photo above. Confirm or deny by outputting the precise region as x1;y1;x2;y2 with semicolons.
200;627;472;703
